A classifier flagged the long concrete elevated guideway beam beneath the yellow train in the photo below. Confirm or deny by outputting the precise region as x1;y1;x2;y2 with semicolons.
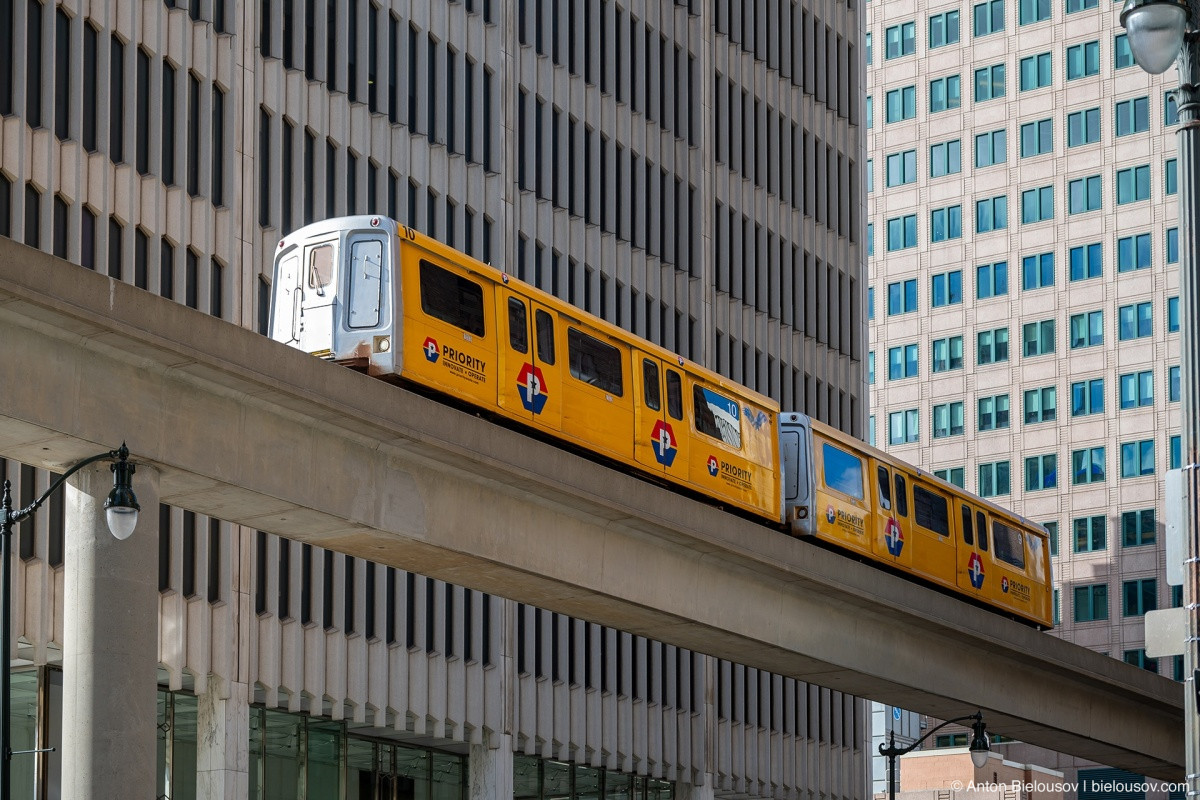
0;237;1184;781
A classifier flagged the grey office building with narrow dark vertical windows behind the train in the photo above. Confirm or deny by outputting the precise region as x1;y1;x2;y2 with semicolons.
0;0;868;800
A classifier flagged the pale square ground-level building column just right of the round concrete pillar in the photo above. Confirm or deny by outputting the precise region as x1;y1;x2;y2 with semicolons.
196;679;250;800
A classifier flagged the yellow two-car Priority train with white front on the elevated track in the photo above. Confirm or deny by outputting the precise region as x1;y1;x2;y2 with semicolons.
270;216;1052;627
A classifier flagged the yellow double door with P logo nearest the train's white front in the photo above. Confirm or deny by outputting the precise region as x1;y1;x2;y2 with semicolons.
497;289;563;431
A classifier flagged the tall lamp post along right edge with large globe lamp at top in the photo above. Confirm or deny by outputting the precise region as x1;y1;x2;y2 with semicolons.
1121;0;1200;796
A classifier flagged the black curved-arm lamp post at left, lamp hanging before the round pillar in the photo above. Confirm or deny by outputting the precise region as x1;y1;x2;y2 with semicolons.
0;444;140;800
